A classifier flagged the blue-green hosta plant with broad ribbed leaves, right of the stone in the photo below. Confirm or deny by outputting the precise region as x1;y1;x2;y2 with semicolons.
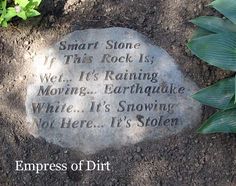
187;0;236;134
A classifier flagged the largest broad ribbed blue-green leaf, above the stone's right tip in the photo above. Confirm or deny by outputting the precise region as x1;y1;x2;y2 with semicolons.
187;33;236;71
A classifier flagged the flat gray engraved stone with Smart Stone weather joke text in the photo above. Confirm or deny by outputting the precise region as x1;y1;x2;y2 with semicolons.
26;28;201;153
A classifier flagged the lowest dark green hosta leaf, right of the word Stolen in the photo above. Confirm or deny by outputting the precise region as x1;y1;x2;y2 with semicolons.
198;109;236;134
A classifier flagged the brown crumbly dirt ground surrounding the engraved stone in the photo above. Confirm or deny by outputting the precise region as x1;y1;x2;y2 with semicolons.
0;0;236;186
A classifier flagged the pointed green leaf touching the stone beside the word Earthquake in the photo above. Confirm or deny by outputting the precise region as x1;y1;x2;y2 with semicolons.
192;77;235;109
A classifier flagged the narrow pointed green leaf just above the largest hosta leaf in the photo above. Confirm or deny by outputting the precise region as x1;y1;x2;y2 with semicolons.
190;16;236;33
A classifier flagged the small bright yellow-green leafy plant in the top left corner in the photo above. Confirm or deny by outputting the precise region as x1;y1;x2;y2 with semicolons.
0;0;41;27
